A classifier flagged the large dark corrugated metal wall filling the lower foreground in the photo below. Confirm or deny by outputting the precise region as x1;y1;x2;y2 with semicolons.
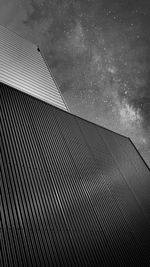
1;84;150;266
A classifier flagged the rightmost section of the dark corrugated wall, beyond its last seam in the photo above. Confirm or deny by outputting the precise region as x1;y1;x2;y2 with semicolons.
94;127;150;221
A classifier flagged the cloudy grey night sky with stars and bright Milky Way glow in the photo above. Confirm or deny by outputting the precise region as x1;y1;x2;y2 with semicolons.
0;0;150;166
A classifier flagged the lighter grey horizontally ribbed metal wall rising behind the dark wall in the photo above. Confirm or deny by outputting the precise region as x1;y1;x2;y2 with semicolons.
0;26;67;110
